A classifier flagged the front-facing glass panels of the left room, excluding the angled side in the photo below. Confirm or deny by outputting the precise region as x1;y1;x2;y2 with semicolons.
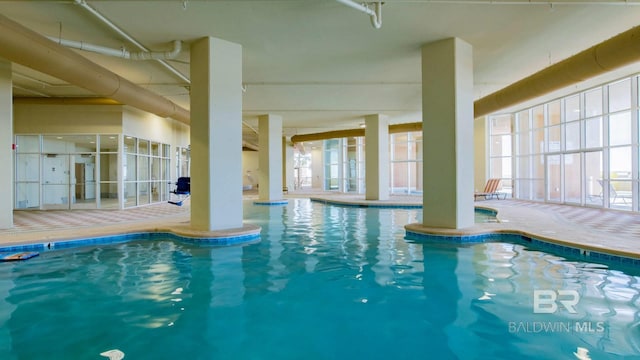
14;134;124;210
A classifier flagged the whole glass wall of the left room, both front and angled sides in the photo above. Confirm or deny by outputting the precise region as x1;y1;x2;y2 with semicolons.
14;134;170;210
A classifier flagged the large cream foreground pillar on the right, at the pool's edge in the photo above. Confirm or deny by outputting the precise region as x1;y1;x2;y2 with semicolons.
422;38;474;229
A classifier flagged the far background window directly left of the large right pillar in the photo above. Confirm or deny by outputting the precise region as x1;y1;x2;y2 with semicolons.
389;131;423;194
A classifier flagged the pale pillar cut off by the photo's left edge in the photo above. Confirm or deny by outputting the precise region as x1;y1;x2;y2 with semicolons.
0;60;15;229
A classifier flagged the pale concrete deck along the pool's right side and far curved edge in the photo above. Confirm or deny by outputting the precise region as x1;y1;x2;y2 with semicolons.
296;193;640;259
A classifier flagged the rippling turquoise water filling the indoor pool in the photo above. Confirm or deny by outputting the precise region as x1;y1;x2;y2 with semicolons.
0;199;640;359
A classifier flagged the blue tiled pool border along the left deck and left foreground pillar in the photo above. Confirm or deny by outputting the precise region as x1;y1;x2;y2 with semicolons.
0;231;260;253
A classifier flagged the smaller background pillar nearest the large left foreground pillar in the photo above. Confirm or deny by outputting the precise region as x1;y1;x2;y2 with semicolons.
258;114;282;201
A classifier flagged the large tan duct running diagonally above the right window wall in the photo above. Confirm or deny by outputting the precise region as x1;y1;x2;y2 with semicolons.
474;26;640;118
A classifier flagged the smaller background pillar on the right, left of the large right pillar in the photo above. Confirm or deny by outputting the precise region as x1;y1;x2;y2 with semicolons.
364;114;389;200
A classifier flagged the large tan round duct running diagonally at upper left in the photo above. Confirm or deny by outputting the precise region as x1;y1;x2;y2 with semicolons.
0;15;190;124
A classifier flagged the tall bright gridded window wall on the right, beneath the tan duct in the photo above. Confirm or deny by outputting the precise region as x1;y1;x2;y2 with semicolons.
504;76;640;211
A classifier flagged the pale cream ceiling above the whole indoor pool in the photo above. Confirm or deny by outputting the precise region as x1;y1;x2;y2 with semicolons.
0;0;640;143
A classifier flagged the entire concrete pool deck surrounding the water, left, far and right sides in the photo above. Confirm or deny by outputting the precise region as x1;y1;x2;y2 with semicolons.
0;192;640;259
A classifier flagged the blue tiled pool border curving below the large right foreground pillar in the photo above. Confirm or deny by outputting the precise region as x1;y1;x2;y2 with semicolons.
405;229;640;268
